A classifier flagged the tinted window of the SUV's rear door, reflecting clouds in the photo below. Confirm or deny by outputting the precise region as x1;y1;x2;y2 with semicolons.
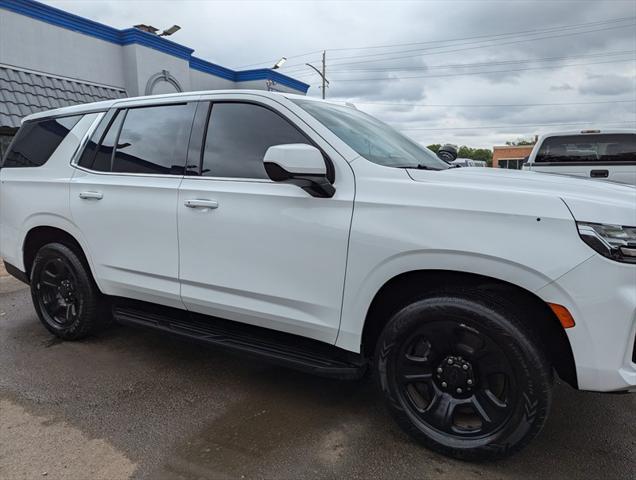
79;103;196;175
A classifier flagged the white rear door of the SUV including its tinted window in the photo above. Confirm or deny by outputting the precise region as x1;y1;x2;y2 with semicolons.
70;103;196;307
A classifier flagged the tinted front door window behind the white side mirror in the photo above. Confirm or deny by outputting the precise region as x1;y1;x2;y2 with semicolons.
201;103;308;178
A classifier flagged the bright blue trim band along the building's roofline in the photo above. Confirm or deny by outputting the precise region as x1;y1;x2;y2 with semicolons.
0;0;309;93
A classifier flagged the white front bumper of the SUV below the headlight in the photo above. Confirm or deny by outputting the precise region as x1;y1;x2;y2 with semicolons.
536;255;636;392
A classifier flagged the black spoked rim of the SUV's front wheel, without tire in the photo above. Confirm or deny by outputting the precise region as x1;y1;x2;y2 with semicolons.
397;321;519;438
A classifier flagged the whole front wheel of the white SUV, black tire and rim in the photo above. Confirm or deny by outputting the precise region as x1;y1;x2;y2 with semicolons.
375;292;552;460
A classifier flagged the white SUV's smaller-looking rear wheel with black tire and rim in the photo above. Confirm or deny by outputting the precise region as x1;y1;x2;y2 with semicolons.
30;243;103;340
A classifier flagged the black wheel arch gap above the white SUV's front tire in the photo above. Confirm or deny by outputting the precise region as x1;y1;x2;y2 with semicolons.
361;270;578;388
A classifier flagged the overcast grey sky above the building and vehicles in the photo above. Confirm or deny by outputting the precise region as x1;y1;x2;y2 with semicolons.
45;0;636;147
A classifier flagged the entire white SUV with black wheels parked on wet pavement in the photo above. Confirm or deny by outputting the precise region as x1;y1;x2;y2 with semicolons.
0;90;636;459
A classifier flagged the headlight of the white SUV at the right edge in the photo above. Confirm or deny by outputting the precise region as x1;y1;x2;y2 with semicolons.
576;222;636;263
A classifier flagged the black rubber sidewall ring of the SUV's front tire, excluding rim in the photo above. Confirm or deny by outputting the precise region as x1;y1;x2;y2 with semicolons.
375;296;550;459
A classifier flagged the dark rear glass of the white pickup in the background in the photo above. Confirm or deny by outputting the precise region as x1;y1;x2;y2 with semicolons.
535;133;636;163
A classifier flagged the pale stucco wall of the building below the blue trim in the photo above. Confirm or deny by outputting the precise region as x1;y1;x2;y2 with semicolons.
0;8;301;96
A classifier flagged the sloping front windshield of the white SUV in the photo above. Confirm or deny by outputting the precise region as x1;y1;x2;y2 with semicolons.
293;99;449;170
